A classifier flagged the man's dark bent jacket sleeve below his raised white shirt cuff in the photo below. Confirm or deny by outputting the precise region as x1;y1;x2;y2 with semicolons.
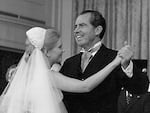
118;64;149;94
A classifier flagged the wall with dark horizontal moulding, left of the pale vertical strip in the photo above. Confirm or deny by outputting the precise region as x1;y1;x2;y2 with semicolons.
0;0;45;50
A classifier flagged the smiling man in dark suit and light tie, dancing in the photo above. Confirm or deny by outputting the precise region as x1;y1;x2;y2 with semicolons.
60;10;148;113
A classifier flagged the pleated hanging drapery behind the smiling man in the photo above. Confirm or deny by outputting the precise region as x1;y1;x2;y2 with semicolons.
72;0;150;79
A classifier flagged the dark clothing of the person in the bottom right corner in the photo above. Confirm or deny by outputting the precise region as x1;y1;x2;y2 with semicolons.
118;90;150;113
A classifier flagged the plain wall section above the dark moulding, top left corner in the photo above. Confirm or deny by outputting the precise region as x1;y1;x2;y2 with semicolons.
0;0;45;20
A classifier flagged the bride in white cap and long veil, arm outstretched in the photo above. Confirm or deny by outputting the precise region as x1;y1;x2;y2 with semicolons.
0;27;121;113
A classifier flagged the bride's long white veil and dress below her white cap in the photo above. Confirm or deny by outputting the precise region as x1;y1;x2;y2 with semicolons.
0;27;67;113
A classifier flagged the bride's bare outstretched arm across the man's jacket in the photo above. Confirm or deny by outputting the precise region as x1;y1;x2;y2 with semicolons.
55;56;121;93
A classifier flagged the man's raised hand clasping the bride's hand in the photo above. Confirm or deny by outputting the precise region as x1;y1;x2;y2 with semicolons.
118;45;133;69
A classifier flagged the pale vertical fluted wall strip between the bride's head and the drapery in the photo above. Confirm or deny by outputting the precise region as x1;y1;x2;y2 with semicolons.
46;0;72;61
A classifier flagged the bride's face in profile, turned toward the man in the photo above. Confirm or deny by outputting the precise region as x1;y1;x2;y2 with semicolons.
47;39;63;63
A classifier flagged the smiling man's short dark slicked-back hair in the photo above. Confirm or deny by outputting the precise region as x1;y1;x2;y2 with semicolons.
80;10;106;39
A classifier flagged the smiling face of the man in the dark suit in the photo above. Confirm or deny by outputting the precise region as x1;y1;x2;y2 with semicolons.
74;13;98;49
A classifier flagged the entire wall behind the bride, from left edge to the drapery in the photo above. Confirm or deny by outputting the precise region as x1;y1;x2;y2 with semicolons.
0;0;72;60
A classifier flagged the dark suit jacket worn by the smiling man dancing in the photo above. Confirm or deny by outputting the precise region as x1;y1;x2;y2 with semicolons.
60;45;148;113
